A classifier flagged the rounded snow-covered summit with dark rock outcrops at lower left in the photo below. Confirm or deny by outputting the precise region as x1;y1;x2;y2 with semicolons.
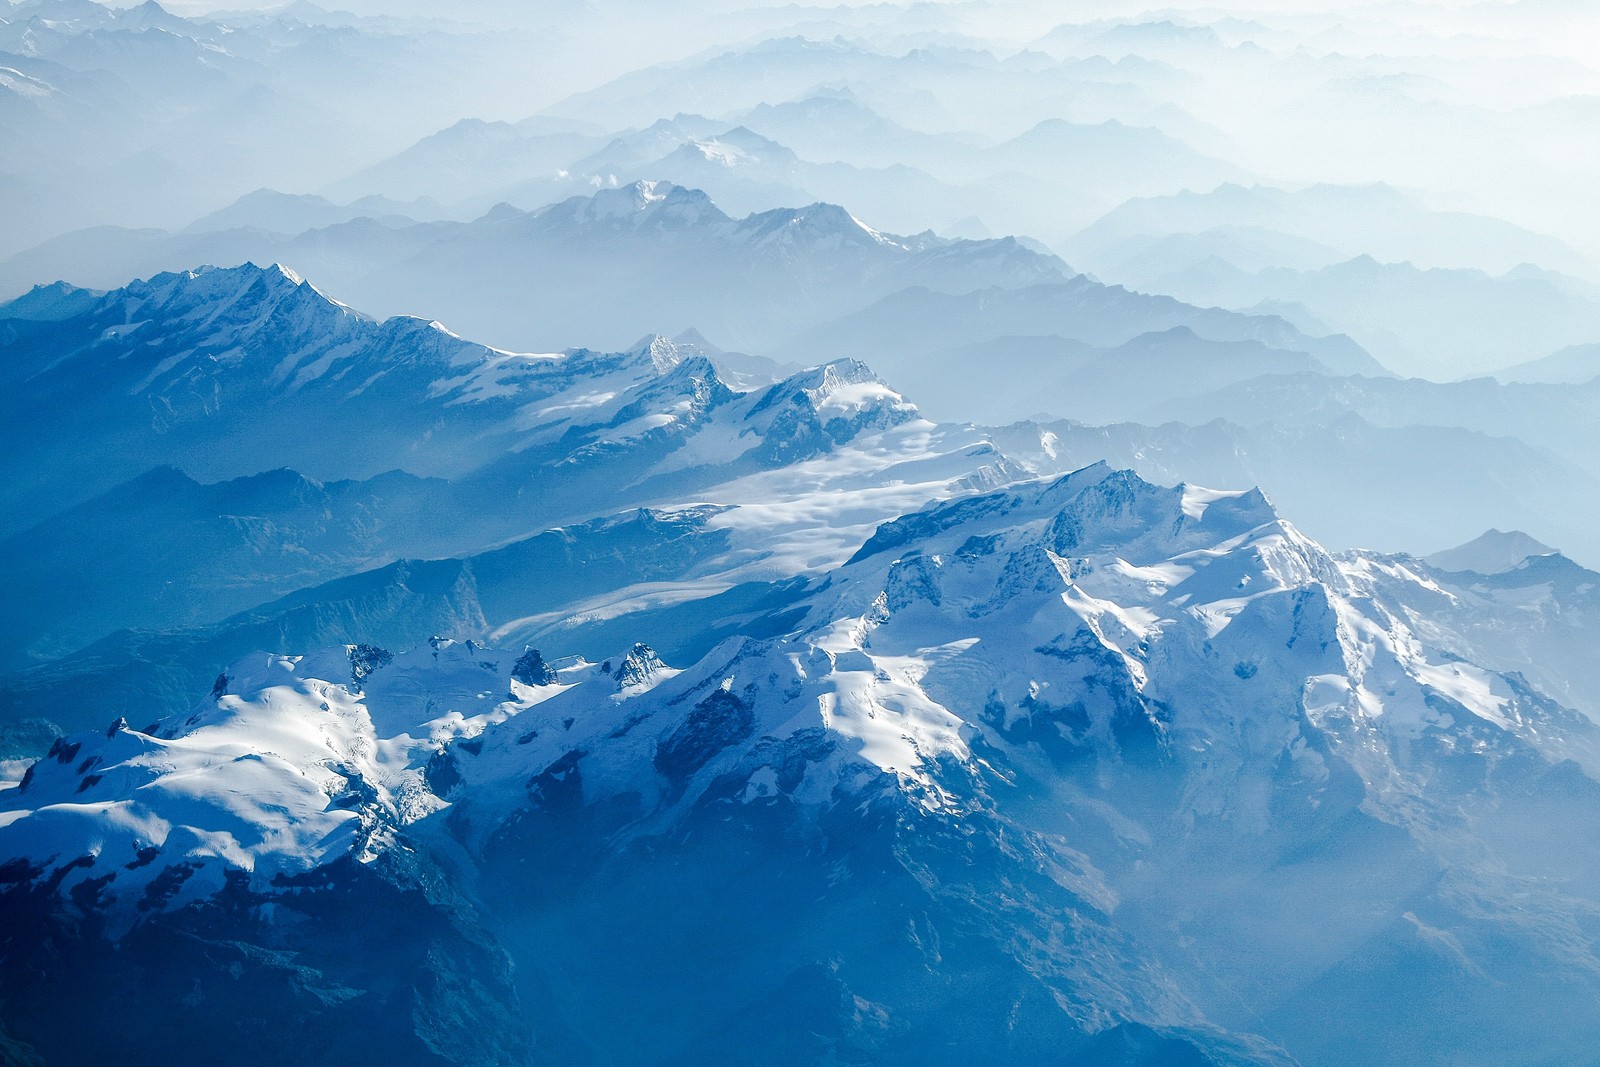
0;641;552;921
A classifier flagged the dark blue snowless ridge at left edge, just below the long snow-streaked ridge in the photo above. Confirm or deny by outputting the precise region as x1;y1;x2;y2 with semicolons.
0;467;448;667
